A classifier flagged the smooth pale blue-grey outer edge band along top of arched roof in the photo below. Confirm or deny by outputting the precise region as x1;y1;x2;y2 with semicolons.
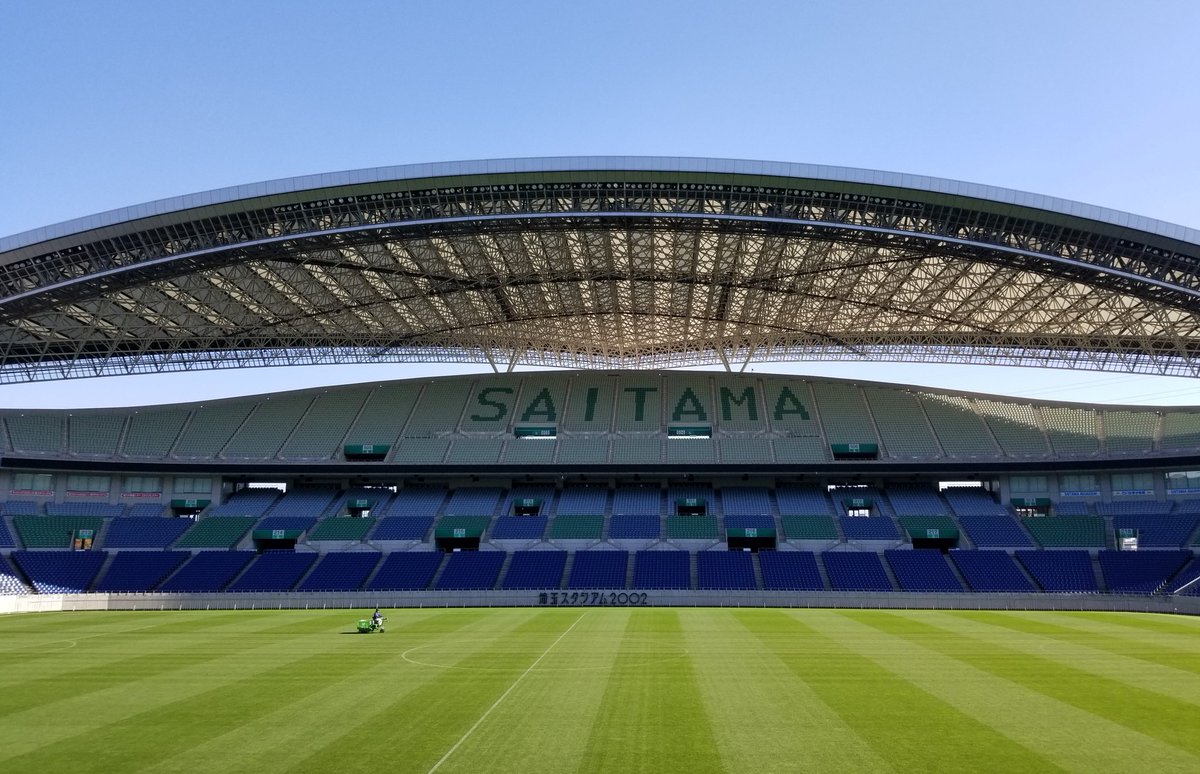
0;156;1200;252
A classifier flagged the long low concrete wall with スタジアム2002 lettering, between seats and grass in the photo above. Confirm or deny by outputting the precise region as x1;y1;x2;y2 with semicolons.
0;590;1200;616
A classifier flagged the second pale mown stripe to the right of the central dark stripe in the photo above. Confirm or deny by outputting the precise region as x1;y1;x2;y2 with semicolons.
820;611;1200;772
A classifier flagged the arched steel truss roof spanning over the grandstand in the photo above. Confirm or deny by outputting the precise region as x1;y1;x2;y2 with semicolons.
0;158;1200;383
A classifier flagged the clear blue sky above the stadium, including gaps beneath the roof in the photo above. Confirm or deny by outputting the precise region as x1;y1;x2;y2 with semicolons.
0;0;1200;406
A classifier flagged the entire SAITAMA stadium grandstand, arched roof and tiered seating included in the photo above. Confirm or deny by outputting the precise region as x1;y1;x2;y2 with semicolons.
0;157;1200;613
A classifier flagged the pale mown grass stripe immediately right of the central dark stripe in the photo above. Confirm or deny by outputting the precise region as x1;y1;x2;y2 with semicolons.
700;610;890;774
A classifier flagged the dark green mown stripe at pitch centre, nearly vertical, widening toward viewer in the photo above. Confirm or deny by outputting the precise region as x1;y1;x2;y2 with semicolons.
576;608;725;774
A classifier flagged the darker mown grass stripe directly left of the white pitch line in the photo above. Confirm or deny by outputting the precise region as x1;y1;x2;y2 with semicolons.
289;608;580;772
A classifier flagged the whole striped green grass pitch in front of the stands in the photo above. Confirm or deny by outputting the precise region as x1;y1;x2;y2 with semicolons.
0;608;1200;774
